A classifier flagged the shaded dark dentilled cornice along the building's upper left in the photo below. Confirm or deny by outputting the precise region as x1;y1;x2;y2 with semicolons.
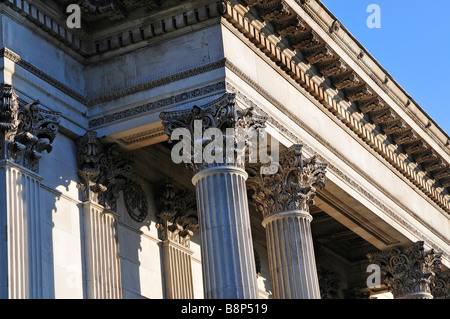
0;0;220;62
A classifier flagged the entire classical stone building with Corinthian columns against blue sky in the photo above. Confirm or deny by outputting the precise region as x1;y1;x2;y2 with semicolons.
0;0;450;299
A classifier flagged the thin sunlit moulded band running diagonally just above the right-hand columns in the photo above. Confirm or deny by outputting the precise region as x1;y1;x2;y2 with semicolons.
226;82;450;261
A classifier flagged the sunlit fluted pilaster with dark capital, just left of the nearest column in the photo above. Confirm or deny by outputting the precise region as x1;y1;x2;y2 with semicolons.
156;182;198;299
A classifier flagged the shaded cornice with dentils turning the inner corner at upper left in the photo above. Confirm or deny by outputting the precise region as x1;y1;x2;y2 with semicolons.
0;0;220;64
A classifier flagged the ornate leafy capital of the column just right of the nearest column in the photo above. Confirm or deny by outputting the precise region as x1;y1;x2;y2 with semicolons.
247;144;327;217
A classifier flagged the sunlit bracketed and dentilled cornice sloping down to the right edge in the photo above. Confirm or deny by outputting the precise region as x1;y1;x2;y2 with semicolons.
222;1;450;212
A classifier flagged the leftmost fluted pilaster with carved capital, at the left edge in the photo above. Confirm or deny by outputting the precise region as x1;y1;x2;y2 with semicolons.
0;84;60;299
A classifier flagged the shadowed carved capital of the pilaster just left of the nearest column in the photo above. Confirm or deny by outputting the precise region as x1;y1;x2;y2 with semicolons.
156;182;199;248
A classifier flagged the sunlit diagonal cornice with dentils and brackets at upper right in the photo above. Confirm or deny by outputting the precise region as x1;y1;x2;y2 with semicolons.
221;1;450;213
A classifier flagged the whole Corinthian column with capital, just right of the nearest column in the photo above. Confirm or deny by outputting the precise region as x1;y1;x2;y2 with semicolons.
249;145;327;299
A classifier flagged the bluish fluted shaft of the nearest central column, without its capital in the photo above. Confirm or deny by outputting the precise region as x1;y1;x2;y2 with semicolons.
193;166;258;299
